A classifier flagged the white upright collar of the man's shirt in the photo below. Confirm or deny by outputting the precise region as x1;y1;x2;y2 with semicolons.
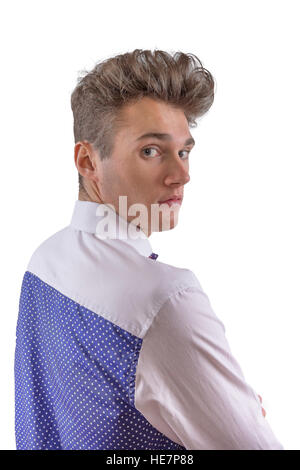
70;199;152;257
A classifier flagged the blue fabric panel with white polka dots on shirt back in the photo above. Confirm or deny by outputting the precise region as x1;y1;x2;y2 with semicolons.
15;271;184;450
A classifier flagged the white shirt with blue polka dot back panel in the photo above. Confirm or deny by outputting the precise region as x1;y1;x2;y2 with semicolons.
15;200;283;450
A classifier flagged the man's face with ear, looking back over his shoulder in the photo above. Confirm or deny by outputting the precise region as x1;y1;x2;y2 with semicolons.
75;97;194;236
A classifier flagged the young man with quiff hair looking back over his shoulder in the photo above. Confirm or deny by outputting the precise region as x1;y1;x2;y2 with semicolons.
15;49;283;450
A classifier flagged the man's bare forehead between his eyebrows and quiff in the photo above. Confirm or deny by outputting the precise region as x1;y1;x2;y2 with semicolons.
115;97;189;137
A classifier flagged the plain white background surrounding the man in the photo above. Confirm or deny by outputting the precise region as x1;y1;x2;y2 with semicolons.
0;0;300;449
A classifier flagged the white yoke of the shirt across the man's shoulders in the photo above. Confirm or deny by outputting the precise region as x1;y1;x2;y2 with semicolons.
27;226;200;338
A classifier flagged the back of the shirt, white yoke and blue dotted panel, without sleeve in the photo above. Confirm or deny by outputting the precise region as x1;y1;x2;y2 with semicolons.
15;201;196;450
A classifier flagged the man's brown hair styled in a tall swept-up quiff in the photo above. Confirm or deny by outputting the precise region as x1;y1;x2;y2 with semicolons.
71;49;214;195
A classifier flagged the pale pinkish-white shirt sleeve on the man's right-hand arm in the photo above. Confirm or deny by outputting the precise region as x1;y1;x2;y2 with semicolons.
135;287;284;450
